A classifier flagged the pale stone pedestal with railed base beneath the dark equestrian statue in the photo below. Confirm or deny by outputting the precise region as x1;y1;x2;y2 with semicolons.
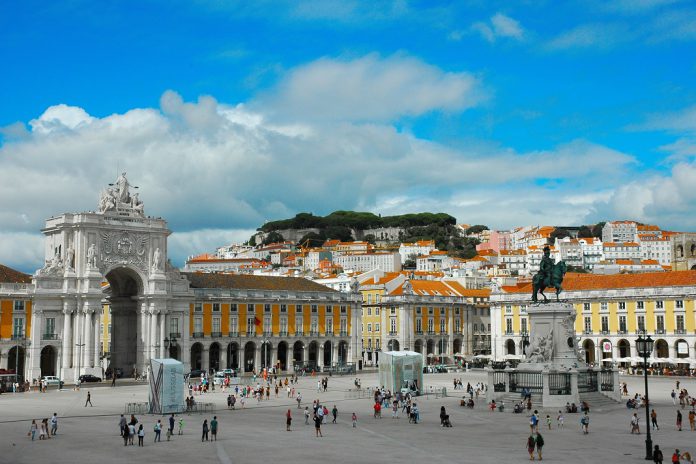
487;302;621;409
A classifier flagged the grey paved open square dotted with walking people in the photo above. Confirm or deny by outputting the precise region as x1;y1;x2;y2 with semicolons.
0;372;696;464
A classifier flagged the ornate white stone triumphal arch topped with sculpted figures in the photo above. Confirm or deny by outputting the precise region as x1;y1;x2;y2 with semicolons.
27;173;193;380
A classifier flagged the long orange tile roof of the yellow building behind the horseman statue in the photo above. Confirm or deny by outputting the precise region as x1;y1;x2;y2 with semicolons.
502;271;696;294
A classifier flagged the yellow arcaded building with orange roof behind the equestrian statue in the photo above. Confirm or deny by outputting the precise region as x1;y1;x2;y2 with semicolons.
491;271;696;364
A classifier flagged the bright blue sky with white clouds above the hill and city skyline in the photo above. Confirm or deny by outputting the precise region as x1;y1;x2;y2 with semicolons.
0;0;696;270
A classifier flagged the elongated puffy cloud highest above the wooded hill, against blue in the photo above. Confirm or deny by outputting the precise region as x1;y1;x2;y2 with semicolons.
256;54;484;122
